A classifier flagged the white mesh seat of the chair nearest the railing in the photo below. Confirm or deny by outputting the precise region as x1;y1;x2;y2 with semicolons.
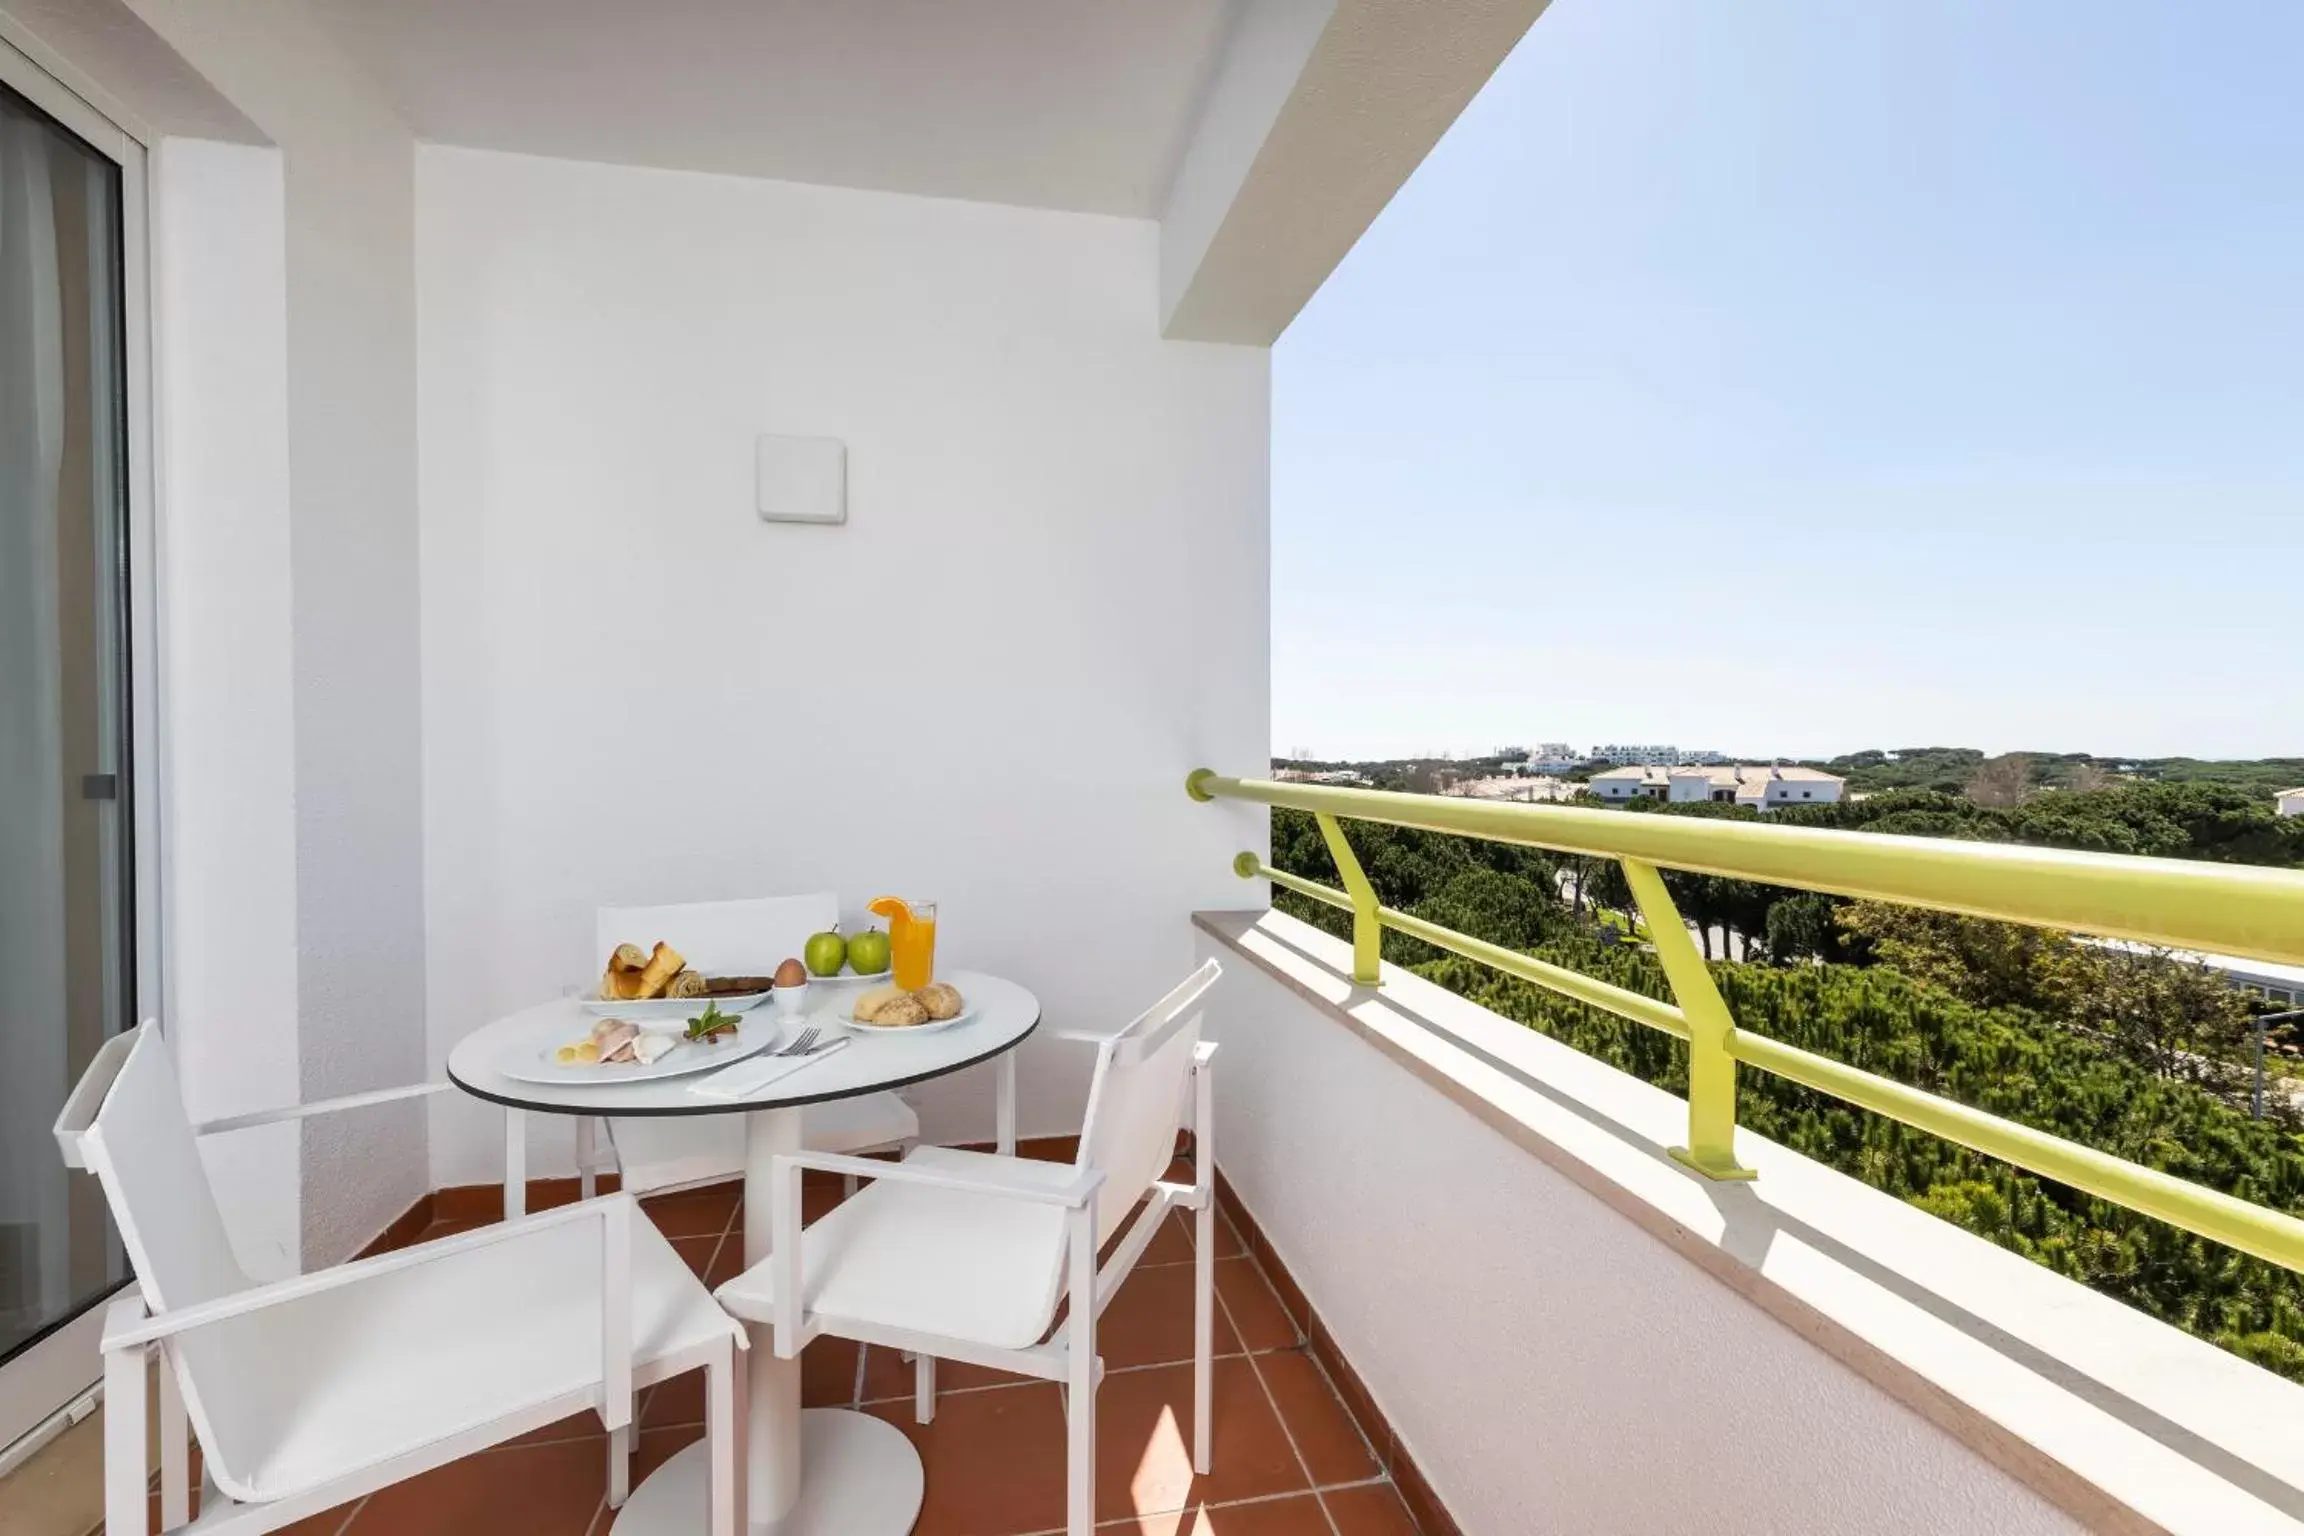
719;1147;1074;1349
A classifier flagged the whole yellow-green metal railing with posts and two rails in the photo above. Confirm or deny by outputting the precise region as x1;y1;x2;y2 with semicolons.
1184;769;2304;1271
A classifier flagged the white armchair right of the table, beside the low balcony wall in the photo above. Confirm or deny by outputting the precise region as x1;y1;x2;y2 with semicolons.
719;960;1221;1536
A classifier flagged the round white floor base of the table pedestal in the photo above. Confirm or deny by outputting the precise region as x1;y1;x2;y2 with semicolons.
608;1407;926;1536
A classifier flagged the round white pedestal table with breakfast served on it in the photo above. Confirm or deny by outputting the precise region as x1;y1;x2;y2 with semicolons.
447;972;1039;1536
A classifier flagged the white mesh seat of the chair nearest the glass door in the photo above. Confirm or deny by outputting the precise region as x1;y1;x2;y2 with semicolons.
187;1221;728;1501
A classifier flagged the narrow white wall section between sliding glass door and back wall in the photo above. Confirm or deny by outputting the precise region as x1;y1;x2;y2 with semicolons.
100;0;429;1273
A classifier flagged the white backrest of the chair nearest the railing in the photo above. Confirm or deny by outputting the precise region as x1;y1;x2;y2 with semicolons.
1078;960;1223;1244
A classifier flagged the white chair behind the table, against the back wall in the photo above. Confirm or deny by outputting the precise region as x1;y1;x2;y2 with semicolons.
571;891;919;1209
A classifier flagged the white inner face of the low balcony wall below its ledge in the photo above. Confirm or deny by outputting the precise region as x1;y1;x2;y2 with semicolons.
1200;919;2101;1536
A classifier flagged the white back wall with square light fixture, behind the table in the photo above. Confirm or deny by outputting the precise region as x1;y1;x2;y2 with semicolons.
417;145;1270;1184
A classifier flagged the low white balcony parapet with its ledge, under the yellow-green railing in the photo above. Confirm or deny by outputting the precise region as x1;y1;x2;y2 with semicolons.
1193;912;2304;1536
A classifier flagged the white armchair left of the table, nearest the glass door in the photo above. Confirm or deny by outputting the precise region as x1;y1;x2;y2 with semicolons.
55;1022;744;1536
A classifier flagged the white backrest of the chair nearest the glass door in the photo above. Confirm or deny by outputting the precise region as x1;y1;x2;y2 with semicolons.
55;1022;251;1313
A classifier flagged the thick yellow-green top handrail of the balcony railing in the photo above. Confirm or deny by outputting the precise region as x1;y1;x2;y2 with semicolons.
1187;769;2304;965
